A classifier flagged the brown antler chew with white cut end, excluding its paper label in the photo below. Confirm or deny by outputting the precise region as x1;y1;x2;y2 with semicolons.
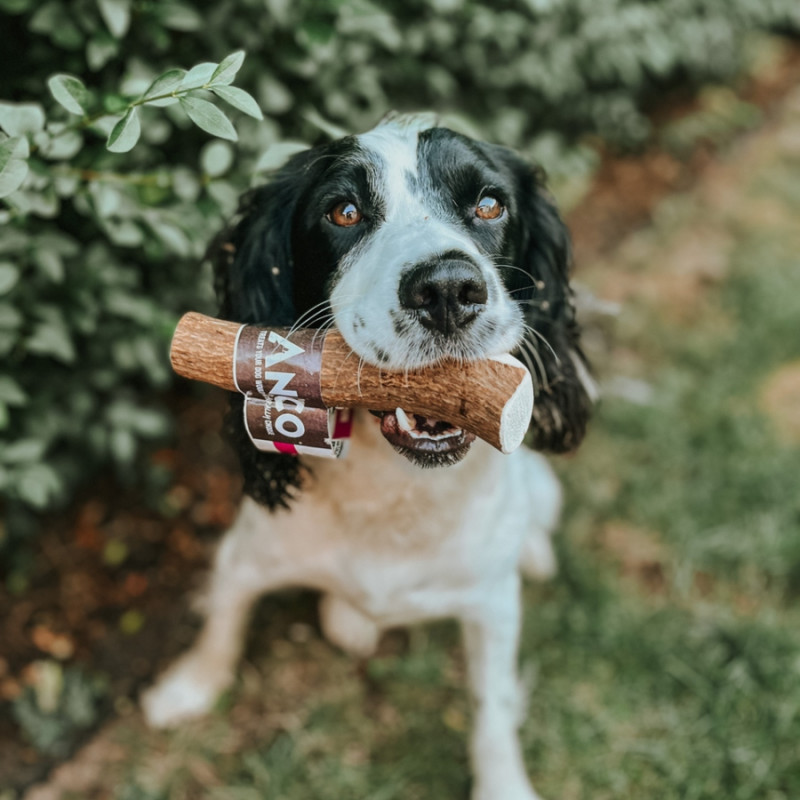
170;312;533;453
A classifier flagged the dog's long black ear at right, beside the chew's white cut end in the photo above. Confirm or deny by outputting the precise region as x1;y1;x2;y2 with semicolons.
505;156;596;453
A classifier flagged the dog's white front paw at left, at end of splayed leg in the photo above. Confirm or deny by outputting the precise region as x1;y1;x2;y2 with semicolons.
141;657;232;728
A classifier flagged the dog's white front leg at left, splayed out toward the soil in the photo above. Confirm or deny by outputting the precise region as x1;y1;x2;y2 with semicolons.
142;513;282;728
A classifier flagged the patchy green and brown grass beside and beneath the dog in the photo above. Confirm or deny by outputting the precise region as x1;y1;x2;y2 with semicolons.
39;95;800;800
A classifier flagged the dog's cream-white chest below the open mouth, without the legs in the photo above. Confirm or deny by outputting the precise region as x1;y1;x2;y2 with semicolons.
258;412;524;624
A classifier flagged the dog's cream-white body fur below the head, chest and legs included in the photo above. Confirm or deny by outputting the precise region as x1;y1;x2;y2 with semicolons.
143;413;561;800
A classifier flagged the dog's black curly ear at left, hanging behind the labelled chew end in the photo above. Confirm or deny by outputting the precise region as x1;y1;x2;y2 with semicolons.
209;152;316;509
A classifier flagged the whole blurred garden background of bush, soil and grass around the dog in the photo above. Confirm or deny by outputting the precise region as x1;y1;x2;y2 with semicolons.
0;0;800;800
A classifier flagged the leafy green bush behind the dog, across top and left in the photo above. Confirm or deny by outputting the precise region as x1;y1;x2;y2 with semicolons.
0;0;800;546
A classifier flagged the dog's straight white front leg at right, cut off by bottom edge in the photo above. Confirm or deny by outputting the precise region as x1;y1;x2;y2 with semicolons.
461;574;538;800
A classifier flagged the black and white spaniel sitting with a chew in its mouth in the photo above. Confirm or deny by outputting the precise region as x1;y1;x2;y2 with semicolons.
143;115;595;800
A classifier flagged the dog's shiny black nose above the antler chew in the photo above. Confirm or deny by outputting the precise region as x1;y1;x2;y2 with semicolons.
400;258;489;336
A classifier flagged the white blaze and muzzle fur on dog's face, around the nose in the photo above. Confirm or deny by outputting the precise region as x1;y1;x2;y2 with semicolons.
331;118;522;369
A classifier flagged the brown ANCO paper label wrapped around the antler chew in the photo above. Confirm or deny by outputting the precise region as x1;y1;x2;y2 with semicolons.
233;325;352;458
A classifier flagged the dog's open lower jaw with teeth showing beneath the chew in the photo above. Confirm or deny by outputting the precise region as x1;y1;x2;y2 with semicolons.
372;408;475;467
